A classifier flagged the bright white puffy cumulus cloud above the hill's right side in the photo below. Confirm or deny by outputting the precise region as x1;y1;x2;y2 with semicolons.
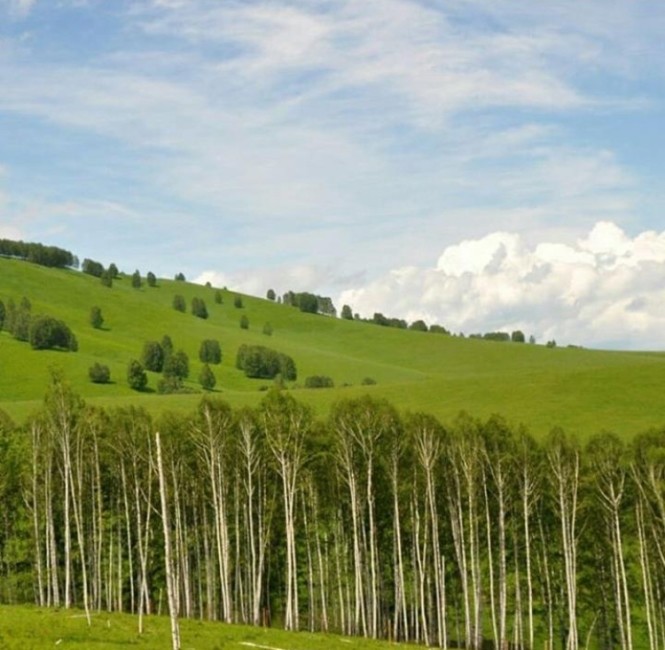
338;221;665;349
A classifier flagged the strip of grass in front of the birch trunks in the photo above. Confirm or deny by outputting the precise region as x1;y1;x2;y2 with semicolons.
0;605;414;650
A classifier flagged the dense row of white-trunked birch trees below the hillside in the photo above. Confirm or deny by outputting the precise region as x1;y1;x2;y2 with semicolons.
0;375;665;650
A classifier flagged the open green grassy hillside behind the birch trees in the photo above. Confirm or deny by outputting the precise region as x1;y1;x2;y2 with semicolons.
0;259;665;435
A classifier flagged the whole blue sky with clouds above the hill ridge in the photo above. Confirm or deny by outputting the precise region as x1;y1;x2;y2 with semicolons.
0;0;665;349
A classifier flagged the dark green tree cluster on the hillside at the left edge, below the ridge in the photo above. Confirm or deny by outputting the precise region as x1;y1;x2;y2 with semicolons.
0;297;78;352
